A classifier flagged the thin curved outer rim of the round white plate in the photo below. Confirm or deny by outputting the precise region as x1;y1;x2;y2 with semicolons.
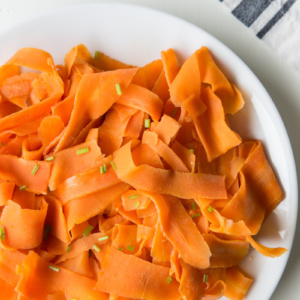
0;1;298;297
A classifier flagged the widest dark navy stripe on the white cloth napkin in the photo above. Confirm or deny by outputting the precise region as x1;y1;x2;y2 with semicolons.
232;0;274;27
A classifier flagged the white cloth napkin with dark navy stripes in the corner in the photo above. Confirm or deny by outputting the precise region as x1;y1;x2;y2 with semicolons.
219;0;300;73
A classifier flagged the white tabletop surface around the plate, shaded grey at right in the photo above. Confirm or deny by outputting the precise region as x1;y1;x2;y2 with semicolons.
0;0;300;300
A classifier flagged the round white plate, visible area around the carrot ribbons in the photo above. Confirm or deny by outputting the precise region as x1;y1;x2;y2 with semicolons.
0;3;298;300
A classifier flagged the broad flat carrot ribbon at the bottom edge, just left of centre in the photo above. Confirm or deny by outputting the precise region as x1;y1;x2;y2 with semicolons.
96;249;179;300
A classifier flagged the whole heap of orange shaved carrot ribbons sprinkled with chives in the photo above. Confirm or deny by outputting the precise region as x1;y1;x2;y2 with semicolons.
0;44;287;300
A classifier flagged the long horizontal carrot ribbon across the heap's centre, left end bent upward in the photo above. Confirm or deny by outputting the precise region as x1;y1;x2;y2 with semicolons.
114;142;227;198
